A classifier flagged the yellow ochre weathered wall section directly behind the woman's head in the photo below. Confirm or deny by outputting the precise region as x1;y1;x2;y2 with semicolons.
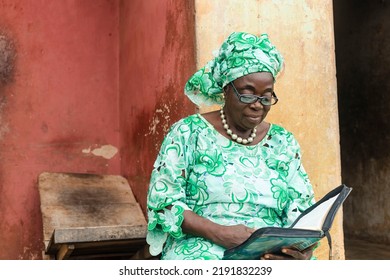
195;0;345;259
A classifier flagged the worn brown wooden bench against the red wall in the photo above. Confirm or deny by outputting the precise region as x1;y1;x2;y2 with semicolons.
38;172;147;259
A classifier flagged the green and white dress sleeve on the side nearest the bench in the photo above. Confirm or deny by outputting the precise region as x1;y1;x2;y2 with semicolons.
146;120;190;256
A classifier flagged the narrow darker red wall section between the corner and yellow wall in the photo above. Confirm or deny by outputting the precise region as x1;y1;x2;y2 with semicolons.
120;0;195;210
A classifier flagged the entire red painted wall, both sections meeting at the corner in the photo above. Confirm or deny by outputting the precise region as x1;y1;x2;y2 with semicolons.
0;0;195;259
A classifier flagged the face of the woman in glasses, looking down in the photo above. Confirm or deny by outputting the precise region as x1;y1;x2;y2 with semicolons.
224;72;274;131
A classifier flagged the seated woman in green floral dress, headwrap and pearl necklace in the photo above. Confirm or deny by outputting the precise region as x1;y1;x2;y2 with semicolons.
147;32;314;260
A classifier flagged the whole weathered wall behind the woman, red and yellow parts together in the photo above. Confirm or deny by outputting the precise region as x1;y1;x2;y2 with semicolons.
0;0;343;259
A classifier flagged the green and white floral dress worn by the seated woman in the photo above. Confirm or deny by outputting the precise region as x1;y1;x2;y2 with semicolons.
147;114;314;260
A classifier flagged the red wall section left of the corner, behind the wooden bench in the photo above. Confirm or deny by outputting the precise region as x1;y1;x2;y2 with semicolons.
0;0;120;259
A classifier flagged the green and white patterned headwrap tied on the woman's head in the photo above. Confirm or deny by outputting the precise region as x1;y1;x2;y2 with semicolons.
184;32;283;106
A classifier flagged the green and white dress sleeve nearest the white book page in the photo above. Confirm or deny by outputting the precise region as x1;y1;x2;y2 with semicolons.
283;137;315;227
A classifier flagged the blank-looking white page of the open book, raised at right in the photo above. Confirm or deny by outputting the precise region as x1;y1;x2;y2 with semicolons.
293;194;340;230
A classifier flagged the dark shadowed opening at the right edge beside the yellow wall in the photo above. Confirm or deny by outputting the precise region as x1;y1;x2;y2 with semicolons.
335;0;390;244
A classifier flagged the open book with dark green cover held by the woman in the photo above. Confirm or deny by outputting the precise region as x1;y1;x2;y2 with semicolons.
223;185;352;260
